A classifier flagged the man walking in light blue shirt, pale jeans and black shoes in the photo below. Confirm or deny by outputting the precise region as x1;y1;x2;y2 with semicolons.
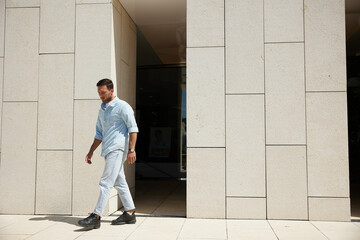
79;79;139;228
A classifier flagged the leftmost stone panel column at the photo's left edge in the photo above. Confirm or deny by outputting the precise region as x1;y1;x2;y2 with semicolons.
0;1;39;214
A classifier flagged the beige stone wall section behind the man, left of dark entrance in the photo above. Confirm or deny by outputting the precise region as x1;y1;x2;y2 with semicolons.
0;0;136;215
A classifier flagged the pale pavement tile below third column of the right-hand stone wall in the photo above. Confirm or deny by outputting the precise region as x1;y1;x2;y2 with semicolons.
269;220;327;240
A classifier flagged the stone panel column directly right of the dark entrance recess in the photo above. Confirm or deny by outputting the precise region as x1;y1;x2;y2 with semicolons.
186;0;225;218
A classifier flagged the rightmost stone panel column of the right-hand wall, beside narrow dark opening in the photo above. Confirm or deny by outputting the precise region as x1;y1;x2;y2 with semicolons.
304;0;350;221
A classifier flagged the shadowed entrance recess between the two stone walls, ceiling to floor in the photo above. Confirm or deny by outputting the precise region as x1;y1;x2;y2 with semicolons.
121;0;186;217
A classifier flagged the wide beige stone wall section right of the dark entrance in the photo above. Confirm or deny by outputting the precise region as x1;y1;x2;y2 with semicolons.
187;0;350;221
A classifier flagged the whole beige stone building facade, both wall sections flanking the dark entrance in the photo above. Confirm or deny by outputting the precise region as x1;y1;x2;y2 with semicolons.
0;0;350;221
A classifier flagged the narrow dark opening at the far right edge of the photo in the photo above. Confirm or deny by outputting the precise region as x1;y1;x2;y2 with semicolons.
346;0;360;221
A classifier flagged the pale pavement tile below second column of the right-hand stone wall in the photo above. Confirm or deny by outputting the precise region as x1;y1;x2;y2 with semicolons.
226;220;277;240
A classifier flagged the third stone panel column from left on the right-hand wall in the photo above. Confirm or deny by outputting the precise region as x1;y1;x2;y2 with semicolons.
264;0;308;220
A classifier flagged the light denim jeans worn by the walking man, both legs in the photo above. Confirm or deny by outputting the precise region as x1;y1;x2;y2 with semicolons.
94;149;135;216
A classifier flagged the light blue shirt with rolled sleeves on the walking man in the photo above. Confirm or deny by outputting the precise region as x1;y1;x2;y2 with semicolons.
95;97;139;156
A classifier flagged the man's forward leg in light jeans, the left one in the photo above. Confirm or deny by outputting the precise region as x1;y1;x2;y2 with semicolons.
94;150;124;217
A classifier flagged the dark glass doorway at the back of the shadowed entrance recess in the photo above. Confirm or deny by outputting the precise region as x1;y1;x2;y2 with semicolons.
136;65;186;179
